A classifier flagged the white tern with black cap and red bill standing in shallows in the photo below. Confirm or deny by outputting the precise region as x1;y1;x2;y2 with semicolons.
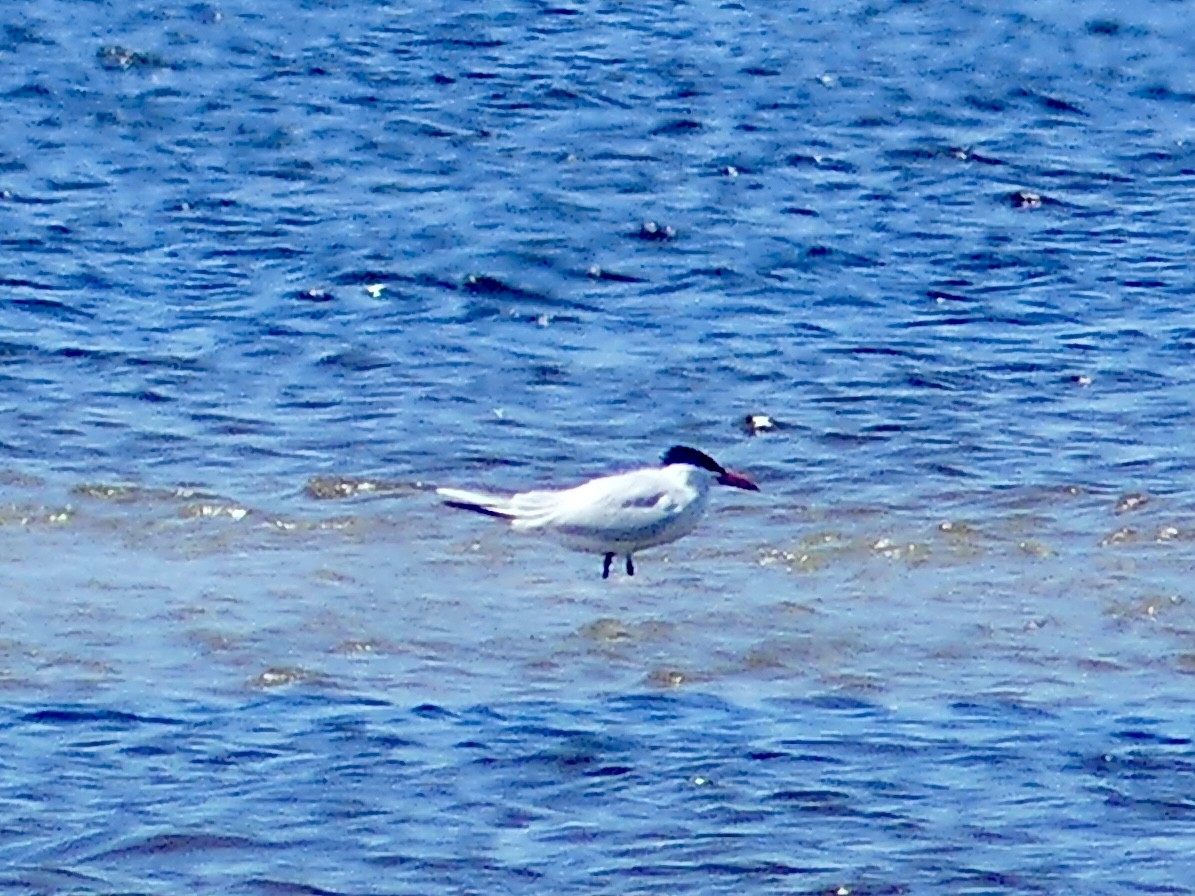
436;444;759;578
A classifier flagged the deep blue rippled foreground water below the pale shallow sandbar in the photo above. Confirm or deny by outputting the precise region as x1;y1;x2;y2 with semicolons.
0;695;1195;894
